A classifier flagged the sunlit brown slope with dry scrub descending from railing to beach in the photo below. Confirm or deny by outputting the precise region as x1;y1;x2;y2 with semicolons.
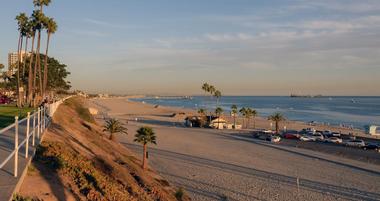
17;97;189;201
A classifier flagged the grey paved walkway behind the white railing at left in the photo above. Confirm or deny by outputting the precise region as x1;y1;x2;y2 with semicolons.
0;114;46;201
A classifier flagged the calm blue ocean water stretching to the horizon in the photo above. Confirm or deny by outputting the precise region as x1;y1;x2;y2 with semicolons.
132;96;380;129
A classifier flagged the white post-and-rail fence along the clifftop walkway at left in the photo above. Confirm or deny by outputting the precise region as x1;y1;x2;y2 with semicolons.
0;96;71;177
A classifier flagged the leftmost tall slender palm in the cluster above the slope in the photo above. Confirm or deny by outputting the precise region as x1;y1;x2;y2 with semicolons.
16;13;28;107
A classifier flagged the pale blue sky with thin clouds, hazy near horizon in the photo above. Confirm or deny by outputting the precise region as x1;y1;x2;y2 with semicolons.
0;0;380;96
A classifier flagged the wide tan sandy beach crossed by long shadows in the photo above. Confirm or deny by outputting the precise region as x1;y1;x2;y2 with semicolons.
88;98;380;200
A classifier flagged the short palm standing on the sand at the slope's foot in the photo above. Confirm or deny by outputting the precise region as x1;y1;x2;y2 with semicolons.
134;126;157;170
